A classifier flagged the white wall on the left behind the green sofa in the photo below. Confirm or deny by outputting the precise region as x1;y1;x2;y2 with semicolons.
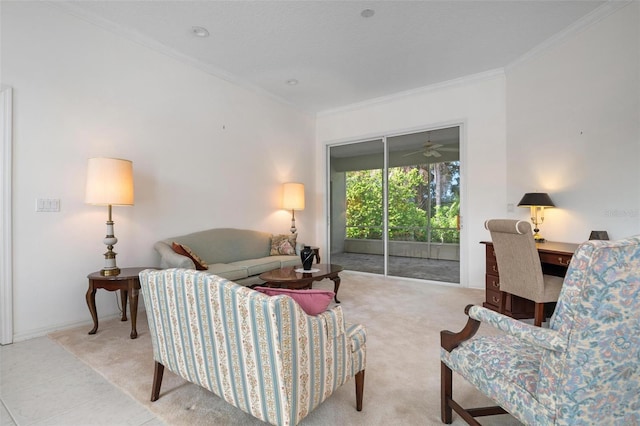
1;2;316;340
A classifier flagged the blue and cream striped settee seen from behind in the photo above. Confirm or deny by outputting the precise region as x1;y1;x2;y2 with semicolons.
140;269;366;425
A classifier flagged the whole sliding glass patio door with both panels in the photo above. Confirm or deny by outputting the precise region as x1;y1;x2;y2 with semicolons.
327;126;461;283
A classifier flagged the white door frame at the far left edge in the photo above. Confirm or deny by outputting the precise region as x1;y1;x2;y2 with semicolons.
0;86;13;345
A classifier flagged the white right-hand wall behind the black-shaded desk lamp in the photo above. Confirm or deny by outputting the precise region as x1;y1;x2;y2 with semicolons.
506;1;640;242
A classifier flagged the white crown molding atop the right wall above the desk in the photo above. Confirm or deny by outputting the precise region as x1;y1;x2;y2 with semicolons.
504;0;637;71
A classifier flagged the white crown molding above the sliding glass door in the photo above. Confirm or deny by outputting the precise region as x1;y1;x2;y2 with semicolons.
316;68;504;117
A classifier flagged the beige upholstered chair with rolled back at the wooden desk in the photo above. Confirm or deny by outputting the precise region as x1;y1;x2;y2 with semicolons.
484;219;562;327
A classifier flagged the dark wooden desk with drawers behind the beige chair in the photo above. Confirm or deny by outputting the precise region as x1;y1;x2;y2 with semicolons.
480;241;578;319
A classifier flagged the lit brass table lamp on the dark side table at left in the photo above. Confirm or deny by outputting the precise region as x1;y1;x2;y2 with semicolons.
85;158;133;276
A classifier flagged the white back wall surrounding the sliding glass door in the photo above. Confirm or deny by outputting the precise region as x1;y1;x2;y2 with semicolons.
316;73;506;288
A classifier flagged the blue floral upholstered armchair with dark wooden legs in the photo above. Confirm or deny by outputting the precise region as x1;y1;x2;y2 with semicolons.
440;236;640;426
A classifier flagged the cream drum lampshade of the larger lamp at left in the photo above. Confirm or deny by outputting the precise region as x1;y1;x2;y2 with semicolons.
85;158;133;206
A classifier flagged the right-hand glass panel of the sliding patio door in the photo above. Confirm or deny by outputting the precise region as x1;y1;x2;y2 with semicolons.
387;127;460;283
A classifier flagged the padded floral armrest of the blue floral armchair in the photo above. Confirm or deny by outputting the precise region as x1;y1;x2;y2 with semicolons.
469;306;567;352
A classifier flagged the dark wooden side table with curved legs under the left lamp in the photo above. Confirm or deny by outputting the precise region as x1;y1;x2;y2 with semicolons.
86;268;153;339
